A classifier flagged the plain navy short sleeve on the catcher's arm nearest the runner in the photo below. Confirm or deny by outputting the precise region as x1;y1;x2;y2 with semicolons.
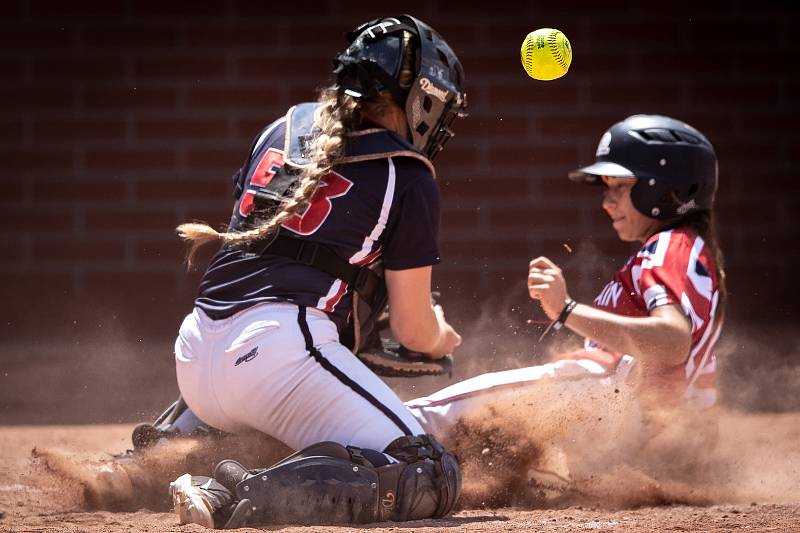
383;160;441;270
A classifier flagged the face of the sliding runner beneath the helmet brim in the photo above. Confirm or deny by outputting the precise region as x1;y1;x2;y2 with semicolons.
602;176;662;242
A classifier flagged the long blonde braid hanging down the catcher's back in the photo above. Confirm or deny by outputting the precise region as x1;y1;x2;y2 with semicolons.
176;88;360;266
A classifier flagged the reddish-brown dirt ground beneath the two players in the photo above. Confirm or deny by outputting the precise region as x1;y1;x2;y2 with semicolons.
0;413;800;533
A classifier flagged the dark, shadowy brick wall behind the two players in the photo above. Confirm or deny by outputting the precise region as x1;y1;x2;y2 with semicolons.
0;0;800;348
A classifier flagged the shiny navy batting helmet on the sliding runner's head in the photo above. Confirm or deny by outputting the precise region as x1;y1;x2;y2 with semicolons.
569;115;717;220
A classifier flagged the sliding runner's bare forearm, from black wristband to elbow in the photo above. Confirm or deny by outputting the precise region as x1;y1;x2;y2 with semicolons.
565;304;691;364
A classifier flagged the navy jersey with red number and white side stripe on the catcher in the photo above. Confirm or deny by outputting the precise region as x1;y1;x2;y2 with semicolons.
195;111;440;330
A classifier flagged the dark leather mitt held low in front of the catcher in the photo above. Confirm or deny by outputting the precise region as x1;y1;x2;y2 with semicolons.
356;337;453;378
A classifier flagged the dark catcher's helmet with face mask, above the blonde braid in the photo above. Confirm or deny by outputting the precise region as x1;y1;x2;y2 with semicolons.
333;15;467;160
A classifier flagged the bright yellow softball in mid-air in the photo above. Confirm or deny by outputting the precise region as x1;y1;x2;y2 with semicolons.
520;28;572;81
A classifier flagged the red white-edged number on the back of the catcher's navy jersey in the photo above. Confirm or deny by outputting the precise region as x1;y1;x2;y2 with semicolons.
234;148;353;235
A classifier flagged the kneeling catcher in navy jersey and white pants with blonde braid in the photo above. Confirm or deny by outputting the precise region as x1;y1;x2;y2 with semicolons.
166;15;466;527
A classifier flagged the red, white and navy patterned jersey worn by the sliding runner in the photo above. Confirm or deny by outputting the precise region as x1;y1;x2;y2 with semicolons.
556;228;721;409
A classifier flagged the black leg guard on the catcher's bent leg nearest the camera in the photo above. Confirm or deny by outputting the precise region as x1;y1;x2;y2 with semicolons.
228;436;461;524
